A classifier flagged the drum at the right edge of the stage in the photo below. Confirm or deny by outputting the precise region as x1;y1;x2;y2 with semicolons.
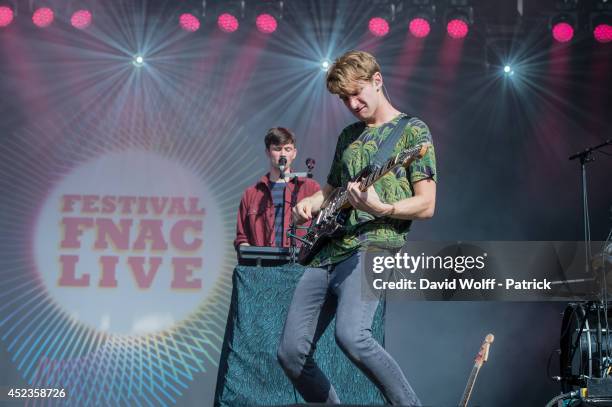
560;302;612;392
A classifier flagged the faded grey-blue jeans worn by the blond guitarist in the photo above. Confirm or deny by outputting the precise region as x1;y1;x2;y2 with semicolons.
278;252;421;406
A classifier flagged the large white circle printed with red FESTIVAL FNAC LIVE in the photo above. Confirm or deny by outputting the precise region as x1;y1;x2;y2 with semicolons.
33;150;225;336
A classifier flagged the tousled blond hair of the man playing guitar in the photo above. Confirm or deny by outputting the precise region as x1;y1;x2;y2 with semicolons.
326;51;380;96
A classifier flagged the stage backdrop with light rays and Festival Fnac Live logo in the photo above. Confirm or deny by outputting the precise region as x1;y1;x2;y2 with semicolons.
0;0;612;406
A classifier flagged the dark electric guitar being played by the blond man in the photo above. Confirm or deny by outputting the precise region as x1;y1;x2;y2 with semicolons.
291;143;431;266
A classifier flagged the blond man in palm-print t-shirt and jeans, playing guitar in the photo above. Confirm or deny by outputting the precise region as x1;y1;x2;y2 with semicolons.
278;51;437;406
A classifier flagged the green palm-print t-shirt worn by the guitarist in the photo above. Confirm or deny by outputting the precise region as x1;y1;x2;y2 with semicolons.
310;113;437;267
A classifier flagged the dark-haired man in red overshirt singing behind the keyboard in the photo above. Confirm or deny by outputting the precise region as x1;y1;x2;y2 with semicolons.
234;127;321;250
